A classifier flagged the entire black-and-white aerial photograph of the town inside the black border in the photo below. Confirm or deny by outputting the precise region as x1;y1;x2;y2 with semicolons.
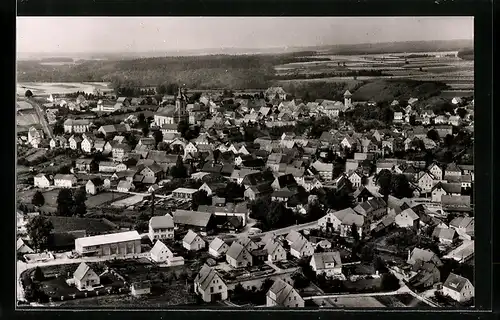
13;16;475;311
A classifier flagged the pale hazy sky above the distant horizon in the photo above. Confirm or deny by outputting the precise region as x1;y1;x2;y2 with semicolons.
16;17;474;53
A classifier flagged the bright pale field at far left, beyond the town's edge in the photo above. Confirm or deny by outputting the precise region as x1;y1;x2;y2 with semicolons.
16;82;112;96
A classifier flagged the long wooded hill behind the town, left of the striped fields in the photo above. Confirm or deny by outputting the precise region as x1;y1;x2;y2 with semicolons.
17;52;314;89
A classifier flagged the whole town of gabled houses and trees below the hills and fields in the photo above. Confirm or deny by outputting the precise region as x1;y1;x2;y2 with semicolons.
17;83;474;308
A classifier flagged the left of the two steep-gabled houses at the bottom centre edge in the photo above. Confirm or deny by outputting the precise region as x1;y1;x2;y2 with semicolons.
194;264;227;302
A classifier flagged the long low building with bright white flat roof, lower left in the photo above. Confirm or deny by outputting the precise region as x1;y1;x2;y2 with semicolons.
75;231;141;256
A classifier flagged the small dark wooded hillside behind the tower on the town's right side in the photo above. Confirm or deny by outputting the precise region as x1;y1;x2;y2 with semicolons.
352;80;448;102
